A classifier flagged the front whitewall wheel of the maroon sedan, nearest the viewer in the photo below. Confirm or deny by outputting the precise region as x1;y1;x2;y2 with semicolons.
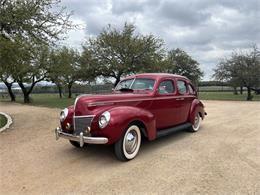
114;125;141;161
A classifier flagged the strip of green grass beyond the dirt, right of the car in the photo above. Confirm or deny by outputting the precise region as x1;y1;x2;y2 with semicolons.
199;92;260;101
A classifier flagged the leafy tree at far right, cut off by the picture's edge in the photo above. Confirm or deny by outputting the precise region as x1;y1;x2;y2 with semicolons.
213;46;260;100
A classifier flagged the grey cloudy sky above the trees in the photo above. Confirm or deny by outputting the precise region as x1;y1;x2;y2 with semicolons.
59;0;260;80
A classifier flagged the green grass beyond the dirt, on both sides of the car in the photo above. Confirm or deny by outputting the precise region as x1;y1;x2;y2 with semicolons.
0;92;260;109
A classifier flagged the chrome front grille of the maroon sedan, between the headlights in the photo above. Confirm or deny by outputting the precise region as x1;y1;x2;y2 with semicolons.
74;116;94;135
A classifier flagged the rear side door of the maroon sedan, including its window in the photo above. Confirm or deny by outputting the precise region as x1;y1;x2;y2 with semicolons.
176;79;194;123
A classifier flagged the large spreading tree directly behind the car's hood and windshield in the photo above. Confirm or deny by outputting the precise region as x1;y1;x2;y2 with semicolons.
83;23;163;85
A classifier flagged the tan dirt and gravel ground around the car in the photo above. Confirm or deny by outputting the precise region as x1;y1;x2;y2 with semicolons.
0;101;260;195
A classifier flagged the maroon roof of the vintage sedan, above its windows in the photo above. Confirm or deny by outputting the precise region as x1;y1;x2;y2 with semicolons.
123;73;189;80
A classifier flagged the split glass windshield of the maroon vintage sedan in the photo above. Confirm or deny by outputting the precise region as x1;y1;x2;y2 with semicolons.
115;78;155;91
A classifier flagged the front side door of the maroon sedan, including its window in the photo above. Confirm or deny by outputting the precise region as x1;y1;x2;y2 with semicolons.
151;78;179;130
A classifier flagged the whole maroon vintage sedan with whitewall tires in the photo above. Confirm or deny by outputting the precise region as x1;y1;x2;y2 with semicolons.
55;73;206;161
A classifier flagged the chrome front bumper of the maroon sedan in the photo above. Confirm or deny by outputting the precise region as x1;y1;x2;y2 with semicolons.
55;127;108;147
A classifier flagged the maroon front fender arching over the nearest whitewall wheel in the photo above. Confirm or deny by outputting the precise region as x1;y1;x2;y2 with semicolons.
93;106;156;144
